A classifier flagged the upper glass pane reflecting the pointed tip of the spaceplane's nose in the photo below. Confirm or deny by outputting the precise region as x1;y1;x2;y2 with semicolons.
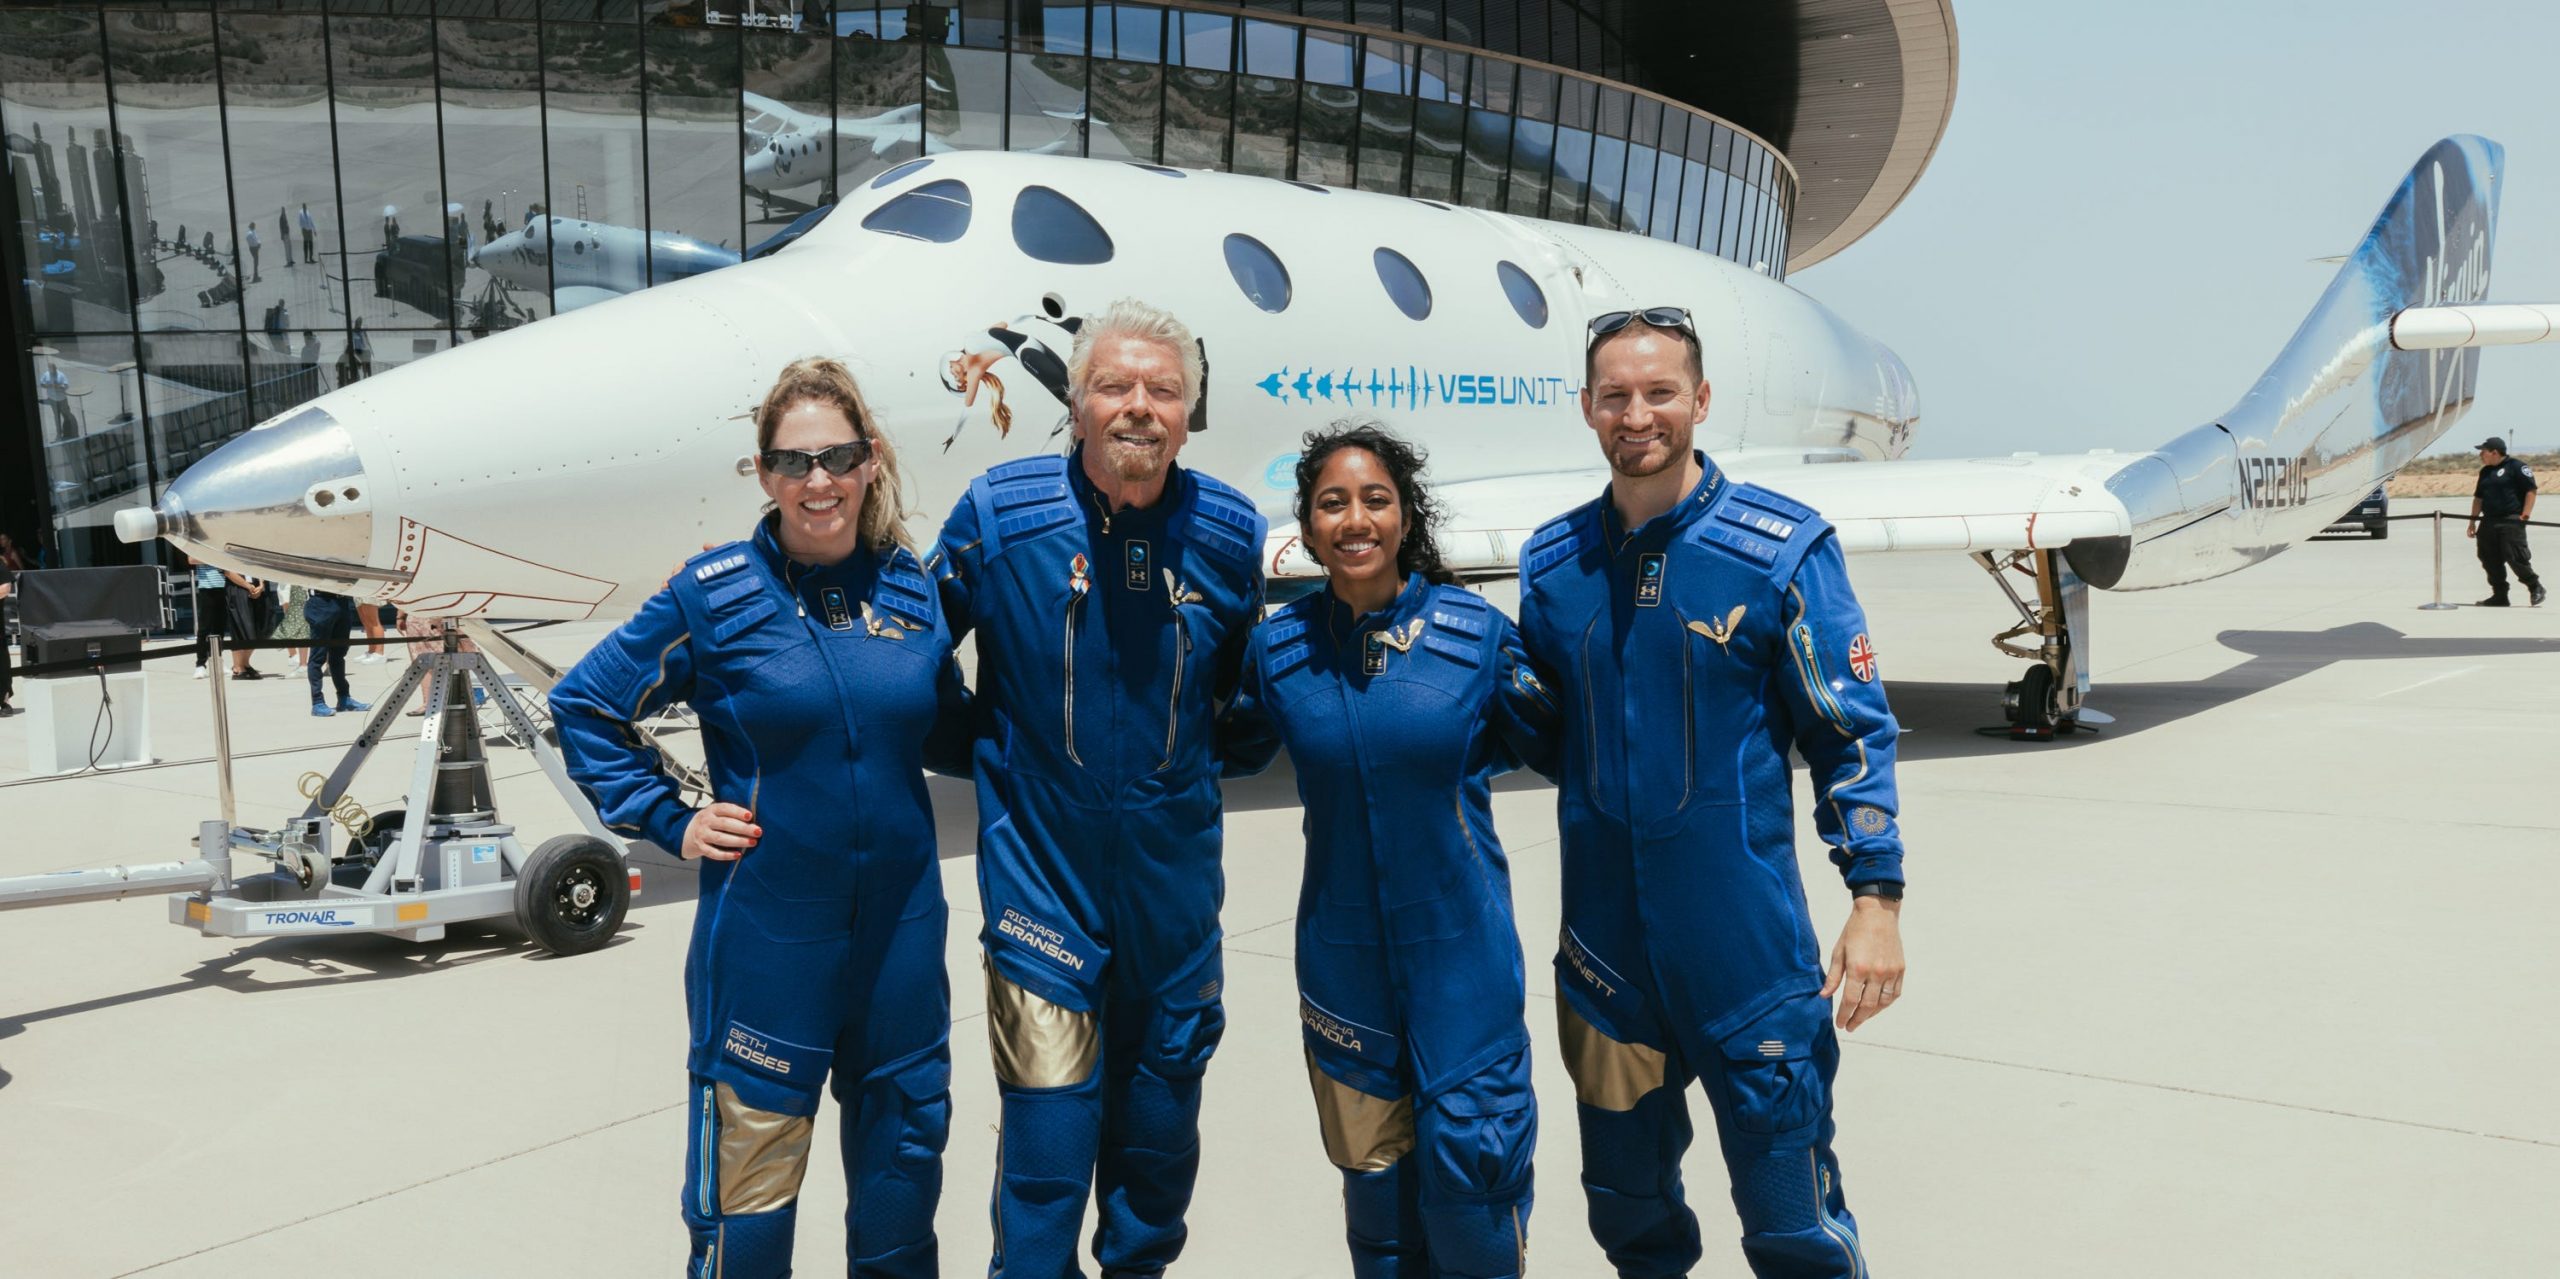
442;18;550;324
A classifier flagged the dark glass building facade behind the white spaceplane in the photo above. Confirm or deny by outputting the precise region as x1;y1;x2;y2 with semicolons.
0;0;1795;565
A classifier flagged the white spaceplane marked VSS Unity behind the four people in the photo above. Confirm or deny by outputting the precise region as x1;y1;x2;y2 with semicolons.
118;138;2555;726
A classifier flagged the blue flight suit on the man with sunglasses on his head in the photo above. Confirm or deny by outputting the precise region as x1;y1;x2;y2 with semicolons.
1521;455;1902;1279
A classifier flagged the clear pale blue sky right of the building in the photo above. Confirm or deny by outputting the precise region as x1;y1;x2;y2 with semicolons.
1792;0;2560;458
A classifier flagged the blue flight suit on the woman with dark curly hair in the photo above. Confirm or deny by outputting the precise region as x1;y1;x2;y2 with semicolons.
1226;573;1556;1279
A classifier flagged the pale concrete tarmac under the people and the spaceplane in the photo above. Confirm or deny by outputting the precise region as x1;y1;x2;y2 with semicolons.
0;501;2560;1279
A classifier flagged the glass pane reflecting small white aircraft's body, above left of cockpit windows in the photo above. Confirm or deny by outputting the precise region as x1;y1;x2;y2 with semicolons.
742;31;829;228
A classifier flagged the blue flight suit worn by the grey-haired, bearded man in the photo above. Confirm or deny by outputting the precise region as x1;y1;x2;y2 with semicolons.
927;453;1265;1279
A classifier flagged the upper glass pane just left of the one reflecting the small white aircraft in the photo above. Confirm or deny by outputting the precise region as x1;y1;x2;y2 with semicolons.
648;26;742;284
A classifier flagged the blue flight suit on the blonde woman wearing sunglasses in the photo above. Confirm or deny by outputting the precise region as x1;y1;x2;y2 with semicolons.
550;517;968;1279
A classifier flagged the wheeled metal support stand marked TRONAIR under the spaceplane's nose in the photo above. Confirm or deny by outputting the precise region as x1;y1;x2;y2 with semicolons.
0;622;640;954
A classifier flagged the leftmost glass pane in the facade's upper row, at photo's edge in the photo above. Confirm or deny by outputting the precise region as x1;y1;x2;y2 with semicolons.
0;8;133;333
